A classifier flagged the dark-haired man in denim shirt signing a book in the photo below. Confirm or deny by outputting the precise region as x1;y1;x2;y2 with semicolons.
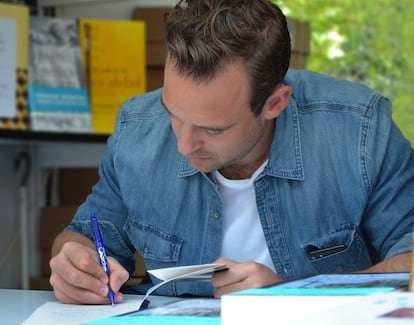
50;0;414;303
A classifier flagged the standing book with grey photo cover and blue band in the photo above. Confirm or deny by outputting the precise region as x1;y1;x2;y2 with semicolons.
29;16;92;133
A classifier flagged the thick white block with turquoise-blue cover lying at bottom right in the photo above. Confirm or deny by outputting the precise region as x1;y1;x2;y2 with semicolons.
221;273;410;325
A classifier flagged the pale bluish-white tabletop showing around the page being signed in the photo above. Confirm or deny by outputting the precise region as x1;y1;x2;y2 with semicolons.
0;289;177;325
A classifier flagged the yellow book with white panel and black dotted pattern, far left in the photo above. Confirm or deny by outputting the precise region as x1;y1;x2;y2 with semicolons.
0;3;29;130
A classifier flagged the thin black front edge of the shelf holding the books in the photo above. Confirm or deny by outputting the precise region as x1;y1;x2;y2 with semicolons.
0;129;109;143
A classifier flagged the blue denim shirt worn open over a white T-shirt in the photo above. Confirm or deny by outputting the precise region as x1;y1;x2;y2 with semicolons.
66;70;414;295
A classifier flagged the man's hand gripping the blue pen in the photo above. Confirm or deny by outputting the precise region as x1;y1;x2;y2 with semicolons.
49;233;129;304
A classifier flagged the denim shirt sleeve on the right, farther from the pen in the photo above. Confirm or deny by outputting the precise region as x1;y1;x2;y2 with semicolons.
360;96;414;259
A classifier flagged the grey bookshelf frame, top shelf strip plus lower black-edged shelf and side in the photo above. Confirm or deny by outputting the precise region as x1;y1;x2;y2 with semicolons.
0;0;171;288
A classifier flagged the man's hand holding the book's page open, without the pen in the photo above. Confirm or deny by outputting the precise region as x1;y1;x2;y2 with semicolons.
211;258;283;298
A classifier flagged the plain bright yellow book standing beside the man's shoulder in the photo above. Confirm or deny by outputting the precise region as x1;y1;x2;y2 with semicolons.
79;19;146;134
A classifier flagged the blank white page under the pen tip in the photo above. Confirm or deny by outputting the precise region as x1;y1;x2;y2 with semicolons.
22;295;142;325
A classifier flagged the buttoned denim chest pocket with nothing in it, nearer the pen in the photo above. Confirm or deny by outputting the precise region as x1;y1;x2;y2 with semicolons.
125;221;184;269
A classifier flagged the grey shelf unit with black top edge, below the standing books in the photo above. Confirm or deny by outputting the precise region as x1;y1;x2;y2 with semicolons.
0;129;108;289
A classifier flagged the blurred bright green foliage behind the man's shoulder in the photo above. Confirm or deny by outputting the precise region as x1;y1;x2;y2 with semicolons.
273;0;414;144
